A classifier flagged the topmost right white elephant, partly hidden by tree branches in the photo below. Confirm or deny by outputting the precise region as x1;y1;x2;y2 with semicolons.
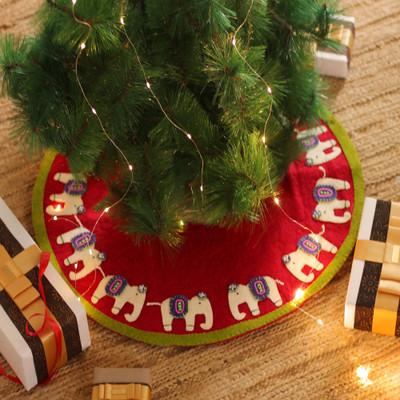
297;125;342;166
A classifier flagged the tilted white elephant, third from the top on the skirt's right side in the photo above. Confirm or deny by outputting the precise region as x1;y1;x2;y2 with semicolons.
282;226;337;283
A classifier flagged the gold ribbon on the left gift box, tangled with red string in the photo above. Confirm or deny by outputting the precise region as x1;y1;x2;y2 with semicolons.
0;246;67;372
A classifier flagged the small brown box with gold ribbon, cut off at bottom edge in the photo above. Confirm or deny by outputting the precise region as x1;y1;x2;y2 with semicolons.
92;368;151;400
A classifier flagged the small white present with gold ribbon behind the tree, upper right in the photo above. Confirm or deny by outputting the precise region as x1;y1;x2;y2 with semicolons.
315;15;356;78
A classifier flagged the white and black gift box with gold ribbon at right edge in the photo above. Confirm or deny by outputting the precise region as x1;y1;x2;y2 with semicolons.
344;198;400;336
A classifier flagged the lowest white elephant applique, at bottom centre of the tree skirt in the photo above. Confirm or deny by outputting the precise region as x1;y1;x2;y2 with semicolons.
147;292;214;332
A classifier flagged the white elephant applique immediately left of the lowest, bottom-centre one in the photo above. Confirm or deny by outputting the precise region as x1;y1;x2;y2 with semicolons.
91;275;147;322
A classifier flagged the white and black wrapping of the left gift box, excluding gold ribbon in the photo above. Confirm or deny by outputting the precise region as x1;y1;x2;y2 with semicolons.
0;198;90;390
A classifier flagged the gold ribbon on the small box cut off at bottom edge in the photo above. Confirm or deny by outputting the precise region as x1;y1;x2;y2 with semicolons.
92;383;151;400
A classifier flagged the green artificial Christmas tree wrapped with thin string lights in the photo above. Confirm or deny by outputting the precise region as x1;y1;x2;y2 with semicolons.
0;0;334;246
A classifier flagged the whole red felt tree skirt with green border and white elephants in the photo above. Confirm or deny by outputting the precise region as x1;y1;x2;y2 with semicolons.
33;118;363;345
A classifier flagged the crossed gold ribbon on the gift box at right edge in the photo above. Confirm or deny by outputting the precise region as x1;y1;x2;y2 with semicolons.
354;202;400;336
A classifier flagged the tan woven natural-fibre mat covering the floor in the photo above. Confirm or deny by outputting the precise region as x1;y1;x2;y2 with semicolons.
0;0;400;400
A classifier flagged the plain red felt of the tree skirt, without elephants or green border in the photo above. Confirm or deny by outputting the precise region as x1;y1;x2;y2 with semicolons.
43;120;354;334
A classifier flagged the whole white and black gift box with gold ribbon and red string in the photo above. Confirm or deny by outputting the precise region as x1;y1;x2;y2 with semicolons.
0;198;90;390
